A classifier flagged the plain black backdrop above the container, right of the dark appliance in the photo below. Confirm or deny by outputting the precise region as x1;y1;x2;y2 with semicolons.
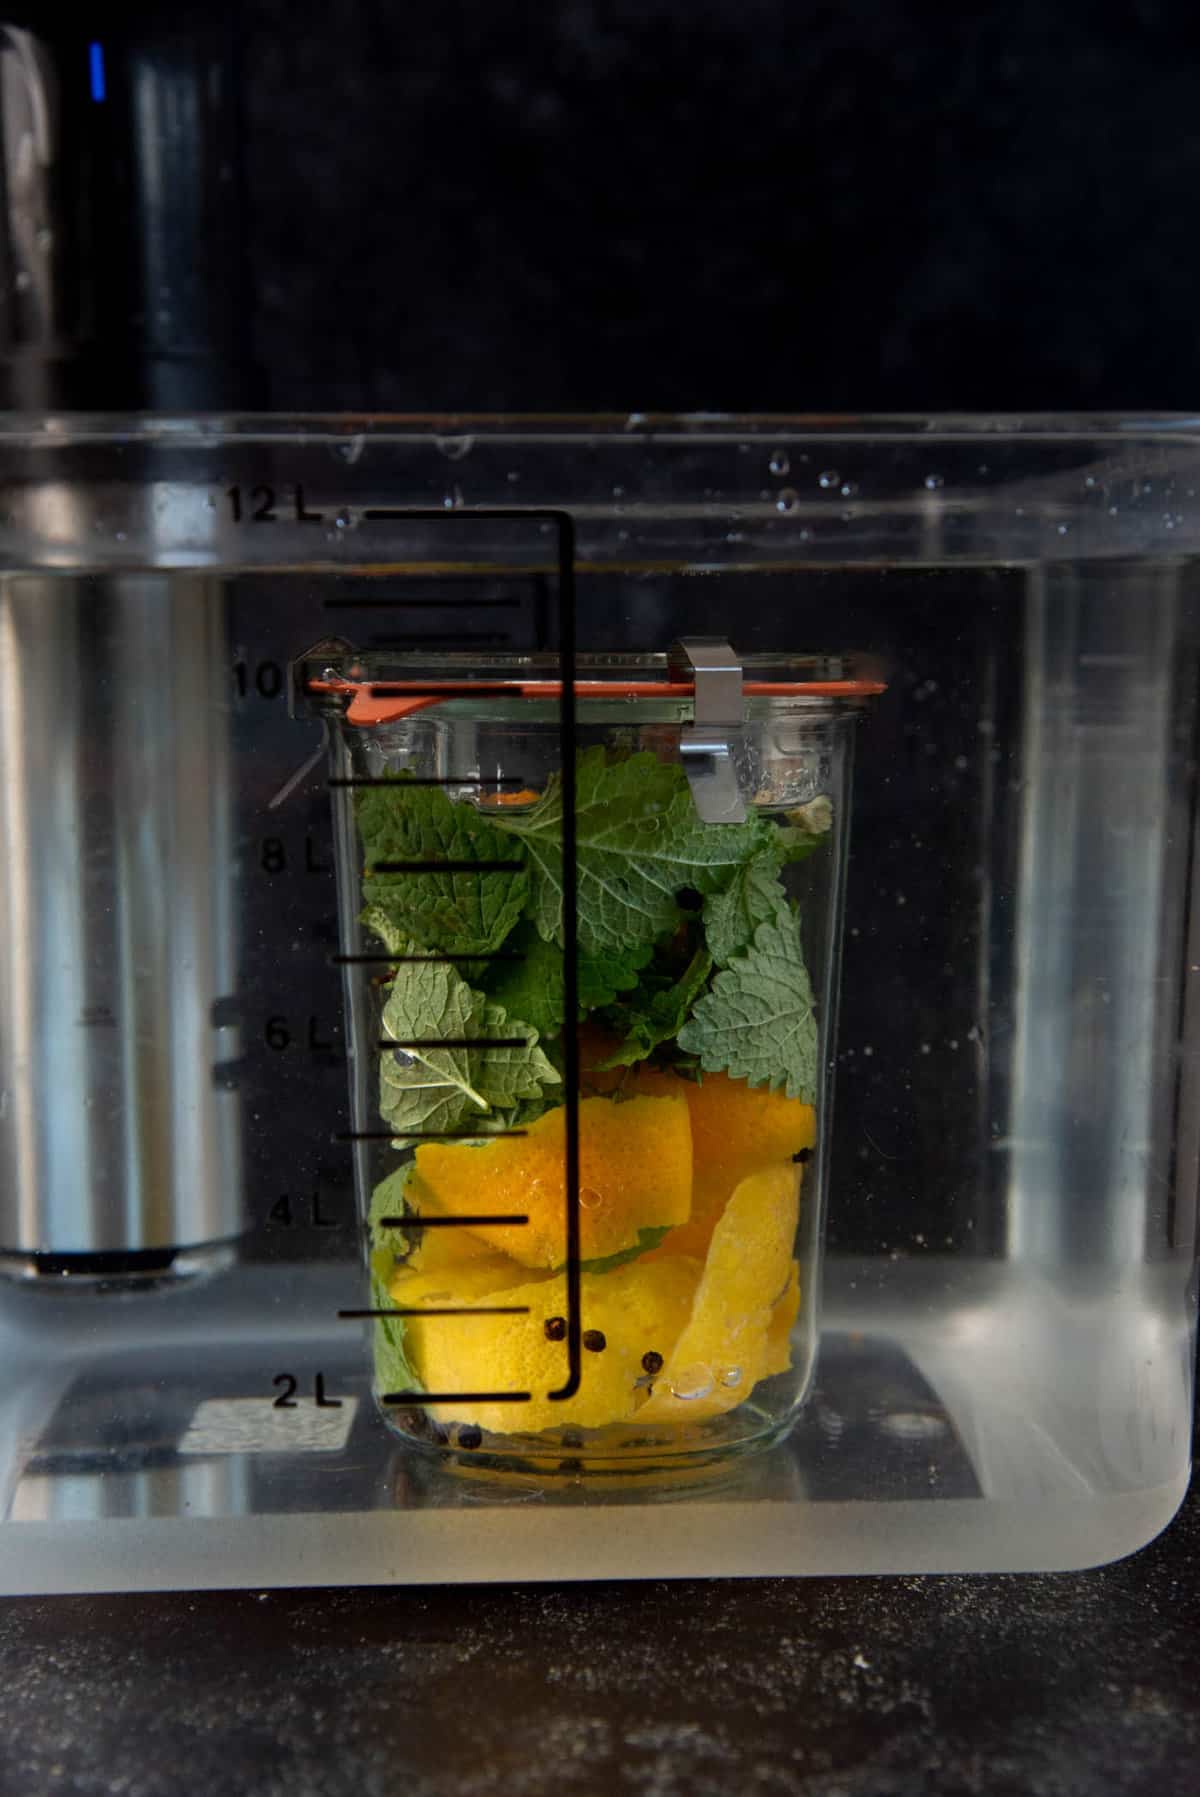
237;0;1200;412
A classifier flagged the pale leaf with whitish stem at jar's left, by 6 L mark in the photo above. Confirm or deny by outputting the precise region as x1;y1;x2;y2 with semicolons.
379;961;560;1139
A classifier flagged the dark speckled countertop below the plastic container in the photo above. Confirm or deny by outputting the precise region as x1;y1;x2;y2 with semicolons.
0;1490;1200;1797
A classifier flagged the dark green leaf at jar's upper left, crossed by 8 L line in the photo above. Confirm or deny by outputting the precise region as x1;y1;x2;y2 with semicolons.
356;776;528;954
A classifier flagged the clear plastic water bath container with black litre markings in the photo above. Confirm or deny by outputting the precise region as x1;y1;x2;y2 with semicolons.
0;415;1200;1590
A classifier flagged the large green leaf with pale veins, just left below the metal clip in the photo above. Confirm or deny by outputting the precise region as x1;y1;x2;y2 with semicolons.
498;748;772;963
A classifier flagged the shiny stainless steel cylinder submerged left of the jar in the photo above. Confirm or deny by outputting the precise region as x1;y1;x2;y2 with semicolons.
0;573;243;1279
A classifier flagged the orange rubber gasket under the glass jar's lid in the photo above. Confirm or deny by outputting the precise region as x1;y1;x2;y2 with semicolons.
307;679;887;728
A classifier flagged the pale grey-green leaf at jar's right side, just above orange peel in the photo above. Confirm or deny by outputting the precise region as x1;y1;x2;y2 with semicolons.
679;911;817;1103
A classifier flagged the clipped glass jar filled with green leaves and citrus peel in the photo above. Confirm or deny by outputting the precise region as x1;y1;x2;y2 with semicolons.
317;645;878;1477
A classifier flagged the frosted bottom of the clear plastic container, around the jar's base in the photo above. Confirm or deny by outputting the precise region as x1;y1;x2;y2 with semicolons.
0;1260;1191;1592
